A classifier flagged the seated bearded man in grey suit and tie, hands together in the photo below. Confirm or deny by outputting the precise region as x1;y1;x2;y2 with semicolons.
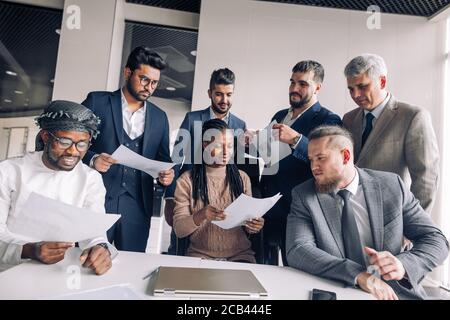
286;126;449;299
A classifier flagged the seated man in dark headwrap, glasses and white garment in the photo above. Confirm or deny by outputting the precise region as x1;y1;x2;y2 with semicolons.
0;100;117;274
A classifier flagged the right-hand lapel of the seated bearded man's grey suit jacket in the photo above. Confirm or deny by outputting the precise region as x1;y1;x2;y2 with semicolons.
357;168;384;251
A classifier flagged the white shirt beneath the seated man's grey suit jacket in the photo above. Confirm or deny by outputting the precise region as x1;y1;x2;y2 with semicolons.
335;169;373;266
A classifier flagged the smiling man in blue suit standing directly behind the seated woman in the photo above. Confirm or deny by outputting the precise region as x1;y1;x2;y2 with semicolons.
165;68;260;253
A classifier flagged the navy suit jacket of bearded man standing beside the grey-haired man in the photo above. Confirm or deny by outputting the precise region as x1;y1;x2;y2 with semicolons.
261;102;342;219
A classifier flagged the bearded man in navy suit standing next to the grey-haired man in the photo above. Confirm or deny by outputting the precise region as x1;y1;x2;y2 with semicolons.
261;60;342;265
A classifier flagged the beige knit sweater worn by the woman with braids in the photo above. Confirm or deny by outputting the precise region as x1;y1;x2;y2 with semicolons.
173;166;255;262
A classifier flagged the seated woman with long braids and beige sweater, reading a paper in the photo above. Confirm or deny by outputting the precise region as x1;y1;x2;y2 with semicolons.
173;119;264;263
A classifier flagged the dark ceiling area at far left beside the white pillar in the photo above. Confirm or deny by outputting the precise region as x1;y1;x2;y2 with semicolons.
0;2;62;117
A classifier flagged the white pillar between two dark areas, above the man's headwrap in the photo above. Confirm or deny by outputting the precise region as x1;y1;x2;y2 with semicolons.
53;0;125;102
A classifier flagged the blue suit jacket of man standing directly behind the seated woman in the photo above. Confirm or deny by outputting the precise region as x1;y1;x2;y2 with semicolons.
166;107;246;197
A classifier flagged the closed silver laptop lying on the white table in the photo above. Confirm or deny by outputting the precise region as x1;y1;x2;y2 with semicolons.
152;266;268;298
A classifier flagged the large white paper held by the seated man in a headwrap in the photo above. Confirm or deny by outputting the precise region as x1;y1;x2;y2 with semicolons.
7;192;120;242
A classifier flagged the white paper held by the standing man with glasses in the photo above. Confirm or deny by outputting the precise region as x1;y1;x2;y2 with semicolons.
111;145;175;179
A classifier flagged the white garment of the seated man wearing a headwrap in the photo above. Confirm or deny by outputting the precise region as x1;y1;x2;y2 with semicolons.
0;151;117;271
